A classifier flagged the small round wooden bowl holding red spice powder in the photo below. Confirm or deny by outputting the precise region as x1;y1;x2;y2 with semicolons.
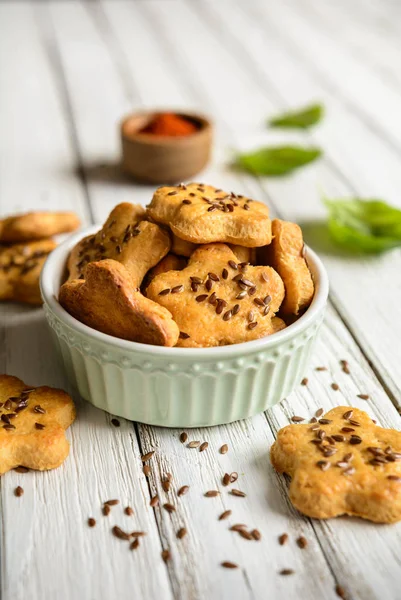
121;111;213;183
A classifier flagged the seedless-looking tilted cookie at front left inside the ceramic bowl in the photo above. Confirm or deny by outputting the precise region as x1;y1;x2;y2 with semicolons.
59;259;179;346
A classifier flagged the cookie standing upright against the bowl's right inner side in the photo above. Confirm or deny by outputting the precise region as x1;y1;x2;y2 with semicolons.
259;219;314;315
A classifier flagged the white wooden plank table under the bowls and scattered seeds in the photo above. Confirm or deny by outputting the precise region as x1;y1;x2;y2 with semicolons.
0;0;401;600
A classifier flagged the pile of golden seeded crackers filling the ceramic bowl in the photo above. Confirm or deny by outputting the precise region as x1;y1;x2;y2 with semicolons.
59;183;314;348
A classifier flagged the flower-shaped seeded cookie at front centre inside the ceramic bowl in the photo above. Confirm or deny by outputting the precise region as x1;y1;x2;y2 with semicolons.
146;244;285;348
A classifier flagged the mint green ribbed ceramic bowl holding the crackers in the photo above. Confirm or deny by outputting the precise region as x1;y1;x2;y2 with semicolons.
41;227;328;427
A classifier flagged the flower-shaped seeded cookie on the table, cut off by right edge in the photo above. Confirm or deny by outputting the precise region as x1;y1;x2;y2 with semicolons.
271;406;401;523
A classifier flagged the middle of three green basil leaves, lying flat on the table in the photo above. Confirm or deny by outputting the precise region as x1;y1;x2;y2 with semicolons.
237;146;322;176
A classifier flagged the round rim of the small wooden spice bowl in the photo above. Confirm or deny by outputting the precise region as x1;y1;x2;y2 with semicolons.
120;108;213;145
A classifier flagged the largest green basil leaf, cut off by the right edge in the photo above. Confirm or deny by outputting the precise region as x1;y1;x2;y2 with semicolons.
324;198;401;253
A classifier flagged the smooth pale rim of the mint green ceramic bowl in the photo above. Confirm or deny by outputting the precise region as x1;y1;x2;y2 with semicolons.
40;225;329;360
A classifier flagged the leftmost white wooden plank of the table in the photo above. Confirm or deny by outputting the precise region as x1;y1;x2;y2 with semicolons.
0;3;171;600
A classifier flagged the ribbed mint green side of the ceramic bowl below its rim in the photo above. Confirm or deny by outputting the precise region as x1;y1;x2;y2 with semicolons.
46;310;324;427
